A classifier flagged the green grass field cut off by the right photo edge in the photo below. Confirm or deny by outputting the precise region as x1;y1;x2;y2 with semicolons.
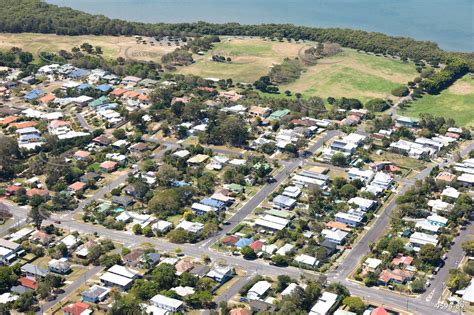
399;75;474;127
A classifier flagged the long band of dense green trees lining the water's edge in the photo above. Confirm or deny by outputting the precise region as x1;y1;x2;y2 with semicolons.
0;0;474;70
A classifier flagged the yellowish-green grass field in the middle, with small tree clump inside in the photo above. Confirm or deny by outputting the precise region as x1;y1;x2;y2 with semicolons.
178;37;306;83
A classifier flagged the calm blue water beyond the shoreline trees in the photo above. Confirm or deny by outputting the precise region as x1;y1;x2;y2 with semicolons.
46;0;474;51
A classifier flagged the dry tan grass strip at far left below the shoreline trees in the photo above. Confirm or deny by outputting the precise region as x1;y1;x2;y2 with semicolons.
0;33;176;62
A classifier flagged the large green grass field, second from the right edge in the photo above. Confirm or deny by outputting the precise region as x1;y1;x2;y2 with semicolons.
281;49;417;101
